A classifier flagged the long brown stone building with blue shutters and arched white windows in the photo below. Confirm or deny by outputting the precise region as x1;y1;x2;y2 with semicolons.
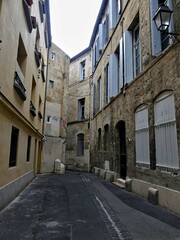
86;0;180;211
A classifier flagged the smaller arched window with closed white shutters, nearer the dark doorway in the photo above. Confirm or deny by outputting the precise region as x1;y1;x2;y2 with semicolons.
135;106;150;164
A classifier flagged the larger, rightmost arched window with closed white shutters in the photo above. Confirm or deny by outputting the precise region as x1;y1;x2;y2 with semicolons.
154;92;179;169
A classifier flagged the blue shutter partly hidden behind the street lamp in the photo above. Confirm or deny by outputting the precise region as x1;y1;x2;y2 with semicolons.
150;0;162;56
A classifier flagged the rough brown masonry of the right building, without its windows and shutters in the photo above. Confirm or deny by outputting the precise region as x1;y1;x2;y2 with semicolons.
90;1;180;189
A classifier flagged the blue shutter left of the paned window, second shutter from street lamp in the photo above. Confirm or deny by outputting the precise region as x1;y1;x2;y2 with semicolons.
124;31;133;84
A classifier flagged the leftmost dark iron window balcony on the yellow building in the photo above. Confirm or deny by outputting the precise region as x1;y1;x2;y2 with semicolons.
14;68;26;101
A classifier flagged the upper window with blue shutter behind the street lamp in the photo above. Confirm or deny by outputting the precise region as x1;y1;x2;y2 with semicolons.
150;0;174;56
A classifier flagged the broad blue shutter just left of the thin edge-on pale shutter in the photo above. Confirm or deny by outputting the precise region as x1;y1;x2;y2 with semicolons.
109;53;118;97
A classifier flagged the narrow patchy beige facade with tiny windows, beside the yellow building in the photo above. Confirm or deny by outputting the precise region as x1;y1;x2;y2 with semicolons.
41;43;70;172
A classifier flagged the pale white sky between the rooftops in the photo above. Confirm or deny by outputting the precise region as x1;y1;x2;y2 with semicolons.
50;0;102;58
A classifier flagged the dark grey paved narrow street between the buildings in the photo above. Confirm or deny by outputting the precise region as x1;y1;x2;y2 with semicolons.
0;172;180;240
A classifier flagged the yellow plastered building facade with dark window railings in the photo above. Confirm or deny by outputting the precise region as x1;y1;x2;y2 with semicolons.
0;0;51;208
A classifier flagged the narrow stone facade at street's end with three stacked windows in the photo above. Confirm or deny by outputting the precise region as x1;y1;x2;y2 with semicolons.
65;48;92;171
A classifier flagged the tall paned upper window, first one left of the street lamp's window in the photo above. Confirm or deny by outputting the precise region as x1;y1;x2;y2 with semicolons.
133;25;141;76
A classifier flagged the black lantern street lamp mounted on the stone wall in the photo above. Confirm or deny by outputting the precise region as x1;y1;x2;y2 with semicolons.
153;3;180;41
